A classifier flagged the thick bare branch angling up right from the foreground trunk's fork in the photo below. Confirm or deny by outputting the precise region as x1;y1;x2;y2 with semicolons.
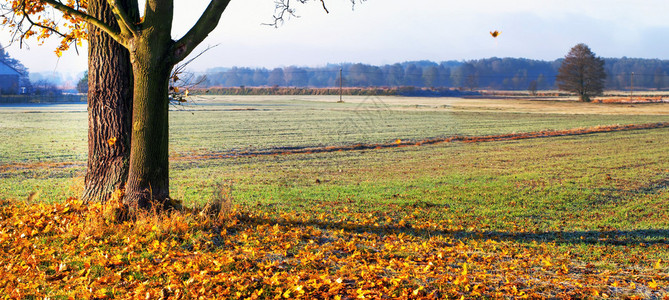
170;0;231;64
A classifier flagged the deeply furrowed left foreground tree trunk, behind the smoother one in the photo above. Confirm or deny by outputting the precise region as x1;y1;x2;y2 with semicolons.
81;0;132;202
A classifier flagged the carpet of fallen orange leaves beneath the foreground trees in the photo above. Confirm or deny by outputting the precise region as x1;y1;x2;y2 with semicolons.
0;199;669;299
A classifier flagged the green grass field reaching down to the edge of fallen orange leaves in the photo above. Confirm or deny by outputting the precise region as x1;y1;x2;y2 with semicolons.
0;97;669;298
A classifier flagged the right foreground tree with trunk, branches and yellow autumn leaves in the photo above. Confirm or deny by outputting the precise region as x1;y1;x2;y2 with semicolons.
3;0;355;208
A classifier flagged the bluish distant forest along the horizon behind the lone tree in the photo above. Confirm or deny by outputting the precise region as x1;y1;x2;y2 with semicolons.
201;57;669;90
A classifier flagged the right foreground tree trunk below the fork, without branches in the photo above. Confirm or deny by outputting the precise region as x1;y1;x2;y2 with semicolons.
124;39;172;209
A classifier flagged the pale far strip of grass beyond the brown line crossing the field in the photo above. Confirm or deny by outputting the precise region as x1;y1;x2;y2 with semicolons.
0;97;669;166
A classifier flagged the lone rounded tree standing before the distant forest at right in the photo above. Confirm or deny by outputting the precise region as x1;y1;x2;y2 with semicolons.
556;44;606;102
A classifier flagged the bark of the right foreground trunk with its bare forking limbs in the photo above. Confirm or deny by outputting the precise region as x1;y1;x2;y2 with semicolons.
82;0;230;209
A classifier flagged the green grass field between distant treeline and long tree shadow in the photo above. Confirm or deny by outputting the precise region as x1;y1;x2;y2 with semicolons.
0;97;669;225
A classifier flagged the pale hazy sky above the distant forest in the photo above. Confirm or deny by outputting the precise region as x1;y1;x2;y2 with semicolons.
0;0;669;72
